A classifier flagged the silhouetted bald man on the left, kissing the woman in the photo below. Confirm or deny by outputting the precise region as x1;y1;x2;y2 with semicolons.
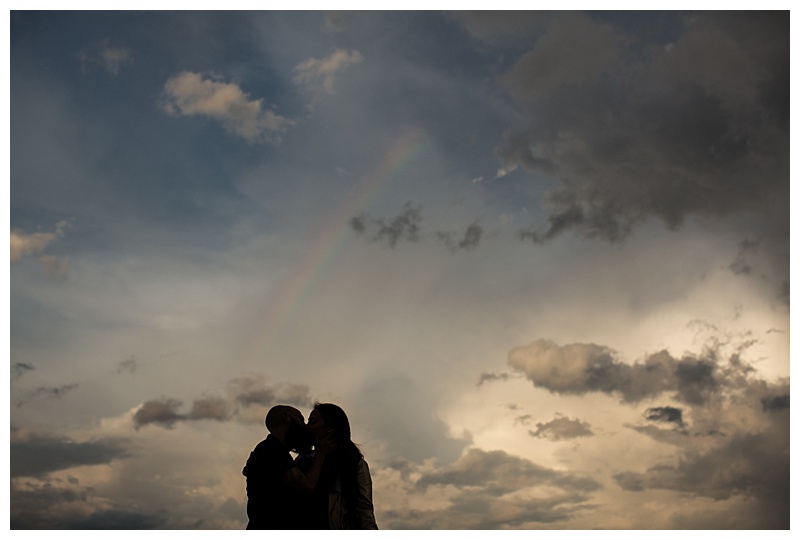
242;405;330;529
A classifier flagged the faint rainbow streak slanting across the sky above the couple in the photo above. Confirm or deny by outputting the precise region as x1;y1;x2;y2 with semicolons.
246;127;427;362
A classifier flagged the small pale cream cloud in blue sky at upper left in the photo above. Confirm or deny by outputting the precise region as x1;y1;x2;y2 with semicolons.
162;71;293;143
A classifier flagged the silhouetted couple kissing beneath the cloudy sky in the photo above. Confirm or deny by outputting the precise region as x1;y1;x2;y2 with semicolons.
242;403;378;529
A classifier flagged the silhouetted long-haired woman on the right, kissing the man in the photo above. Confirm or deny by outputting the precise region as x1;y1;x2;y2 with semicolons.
298;403;378;529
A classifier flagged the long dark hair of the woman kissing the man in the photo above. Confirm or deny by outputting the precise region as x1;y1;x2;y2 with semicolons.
314;403;364;520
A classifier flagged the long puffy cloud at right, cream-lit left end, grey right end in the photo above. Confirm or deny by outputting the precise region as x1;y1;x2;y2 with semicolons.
508;340;728;404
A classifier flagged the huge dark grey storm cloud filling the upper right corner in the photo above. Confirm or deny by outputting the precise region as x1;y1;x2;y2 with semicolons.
482;12;789;294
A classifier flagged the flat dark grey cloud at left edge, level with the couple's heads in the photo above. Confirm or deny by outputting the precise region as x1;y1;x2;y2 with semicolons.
10;434;129;478
